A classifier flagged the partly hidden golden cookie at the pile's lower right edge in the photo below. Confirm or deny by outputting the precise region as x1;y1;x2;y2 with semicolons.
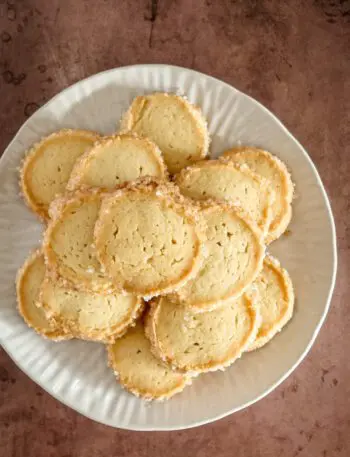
248;256;294;351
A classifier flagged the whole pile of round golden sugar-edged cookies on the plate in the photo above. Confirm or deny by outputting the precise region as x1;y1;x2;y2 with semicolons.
17;93;294;399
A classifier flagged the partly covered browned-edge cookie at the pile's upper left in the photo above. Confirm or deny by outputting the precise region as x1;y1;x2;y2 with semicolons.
20;129;99;219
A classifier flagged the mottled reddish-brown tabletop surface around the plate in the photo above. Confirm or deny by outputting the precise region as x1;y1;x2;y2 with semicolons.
0;0;350;457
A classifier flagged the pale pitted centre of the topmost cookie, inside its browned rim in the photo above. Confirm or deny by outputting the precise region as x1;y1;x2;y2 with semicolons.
98;198;197;287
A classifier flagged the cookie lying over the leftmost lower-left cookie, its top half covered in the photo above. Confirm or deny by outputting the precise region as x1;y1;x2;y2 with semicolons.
39;277;144;343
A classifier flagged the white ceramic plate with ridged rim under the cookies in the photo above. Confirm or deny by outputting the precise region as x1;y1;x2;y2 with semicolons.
0;65;337;430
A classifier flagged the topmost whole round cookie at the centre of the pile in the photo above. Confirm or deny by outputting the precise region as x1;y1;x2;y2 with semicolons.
95;179;206;298
